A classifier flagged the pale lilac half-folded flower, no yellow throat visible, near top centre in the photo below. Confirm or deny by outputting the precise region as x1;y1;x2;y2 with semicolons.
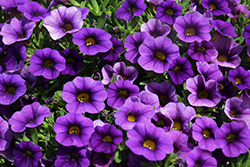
141;18;171;38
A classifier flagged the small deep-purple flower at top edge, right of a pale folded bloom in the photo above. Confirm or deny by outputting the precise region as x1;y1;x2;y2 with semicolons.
155;1;182;25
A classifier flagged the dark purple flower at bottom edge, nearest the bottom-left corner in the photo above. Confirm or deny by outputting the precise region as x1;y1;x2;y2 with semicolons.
13;141;43;167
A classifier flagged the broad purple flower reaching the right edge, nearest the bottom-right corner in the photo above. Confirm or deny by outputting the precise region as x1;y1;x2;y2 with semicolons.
214;121;250;157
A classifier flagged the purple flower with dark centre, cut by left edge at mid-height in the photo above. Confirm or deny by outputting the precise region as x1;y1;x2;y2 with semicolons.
0;74;27;105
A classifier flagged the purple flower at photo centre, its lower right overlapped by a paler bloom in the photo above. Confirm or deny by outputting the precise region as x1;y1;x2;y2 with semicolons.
107;80;139;108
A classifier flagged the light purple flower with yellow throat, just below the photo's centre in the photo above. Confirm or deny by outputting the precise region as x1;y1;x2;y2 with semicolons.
114;101;155;130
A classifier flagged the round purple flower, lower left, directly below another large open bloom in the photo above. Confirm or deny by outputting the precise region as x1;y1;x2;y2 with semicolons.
53;113;95;147
